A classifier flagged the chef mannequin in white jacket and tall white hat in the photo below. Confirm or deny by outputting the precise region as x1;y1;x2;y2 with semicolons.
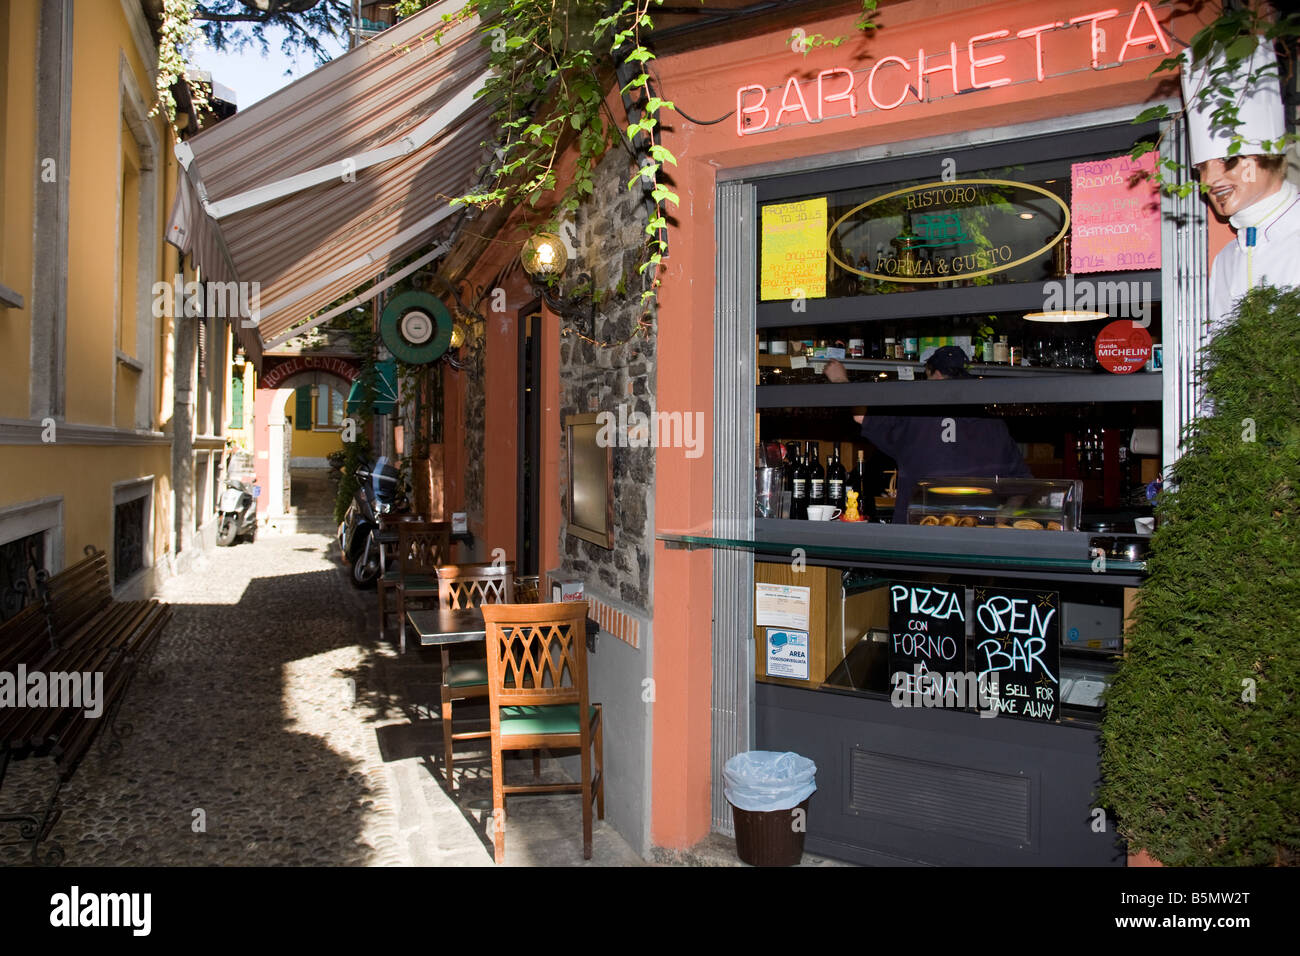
1183;38;1300;336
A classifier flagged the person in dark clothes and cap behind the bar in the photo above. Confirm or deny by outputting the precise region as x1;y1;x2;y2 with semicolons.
826;345;1034;524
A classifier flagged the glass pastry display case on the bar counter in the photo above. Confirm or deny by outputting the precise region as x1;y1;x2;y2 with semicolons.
907;477;1083;531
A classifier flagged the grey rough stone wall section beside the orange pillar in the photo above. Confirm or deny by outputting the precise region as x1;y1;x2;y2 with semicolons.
560;147;655;615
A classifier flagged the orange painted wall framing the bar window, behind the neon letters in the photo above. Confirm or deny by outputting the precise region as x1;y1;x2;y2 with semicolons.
651;0;1195;847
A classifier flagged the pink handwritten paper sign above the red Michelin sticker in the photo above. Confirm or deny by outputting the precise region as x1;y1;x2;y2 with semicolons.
1070;152;1160;272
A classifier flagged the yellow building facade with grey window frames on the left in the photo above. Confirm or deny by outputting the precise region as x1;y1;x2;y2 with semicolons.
0;0;231;613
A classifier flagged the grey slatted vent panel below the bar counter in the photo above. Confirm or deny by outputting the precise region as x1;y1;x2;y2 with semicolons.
846;747;1035;847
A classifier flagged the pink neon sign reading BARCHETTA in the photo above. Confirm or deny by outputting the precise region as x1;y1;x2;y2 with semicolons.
736;0;1171;137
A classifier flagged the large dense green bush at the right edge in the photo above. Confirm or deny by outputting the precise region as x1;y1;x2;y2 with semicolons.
1100;287;1300;865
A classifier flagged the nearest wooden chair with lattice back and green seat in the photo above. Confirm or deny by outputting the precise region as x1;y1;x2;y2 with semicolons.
482;601;605;864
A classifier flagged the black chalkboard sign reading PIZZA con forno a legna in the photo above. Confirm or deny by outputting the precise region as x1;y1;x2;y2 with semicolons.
889;581;966;704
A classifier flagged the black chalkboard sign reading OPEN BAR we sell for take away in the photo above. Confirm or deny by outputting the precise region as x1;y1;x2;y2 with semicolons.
971;588;1061;721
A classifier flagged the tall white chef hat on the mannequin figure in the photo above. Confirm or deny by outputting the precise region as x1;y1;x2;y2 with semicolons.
1183;36;1287;165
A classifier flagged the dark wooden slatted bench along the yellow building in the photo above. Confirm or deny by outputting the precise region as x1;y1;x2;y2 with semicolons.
0;551;172;864
